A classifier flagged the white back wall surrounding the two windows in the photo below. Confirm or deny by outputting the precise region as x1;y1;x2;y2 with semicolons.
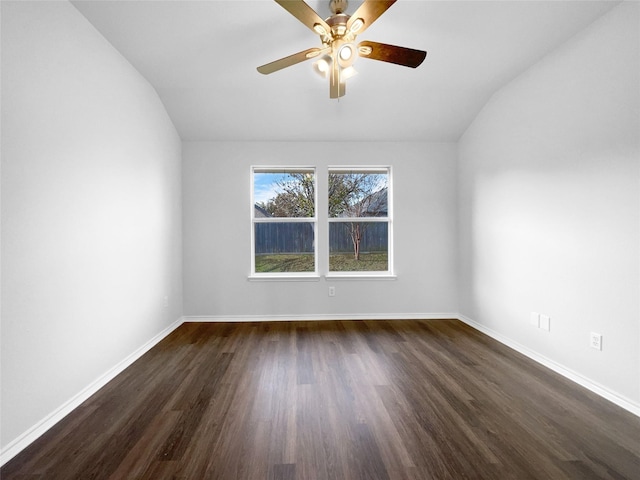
182;142;458;319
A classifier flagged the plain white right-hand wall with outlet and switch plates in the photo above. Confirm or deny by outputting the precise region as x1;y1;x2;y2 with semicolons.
459;2;640;406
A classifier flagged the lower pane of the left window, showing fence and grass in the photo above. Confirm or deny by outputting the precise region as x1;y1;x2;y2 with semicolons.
255;222;315;273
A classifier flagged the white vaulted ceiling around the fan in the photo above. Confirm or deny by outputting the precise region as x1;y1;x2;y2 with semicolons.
73;0;618;141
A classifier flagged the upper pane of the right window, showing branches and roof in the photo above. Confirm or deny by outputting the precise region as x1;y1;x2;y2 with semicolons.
328;171;389;218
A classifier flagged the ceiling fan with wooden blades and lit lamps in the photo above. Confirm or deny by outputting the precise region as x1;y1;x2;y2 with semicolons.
258;0;427;98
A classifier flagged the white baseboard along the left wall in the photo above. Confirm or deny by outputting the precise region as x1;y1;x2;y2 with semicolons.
0;318;183;466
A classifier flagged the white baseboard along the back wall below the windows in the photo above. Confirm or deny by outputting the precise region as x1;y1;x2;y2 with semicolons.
183;312;458;322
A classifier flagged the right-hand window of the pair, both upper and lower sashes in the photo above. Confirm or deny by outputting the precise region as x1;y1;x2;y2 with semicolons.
327;167;392;275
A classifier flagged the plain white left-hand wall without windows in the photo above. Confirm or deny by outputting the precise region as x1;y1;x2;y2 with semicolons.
0;1;182;451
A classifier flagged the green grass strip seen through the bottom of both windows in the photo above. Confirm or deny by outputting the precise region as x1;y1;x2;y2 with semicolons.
256;253;388;273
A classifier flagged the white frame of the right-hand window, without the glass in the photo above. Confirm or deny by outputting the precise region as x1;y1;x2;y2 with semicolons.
323;165;396;280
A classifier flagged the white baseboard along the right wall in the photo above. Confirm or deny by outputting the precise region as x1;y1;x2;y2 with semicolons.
456;314;640;417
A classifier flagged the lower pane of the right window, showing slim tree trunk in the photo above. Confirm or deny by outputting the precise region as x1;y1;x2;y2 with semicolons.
329;222;389;272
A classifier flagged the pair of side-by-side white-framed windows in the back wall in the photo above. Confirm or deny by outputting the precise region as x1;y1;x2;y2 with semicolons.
251;166;393;279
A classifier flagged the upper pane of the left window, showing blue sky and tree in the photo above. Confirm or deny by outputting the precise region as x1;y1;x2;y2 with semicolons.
253;170;315;218
